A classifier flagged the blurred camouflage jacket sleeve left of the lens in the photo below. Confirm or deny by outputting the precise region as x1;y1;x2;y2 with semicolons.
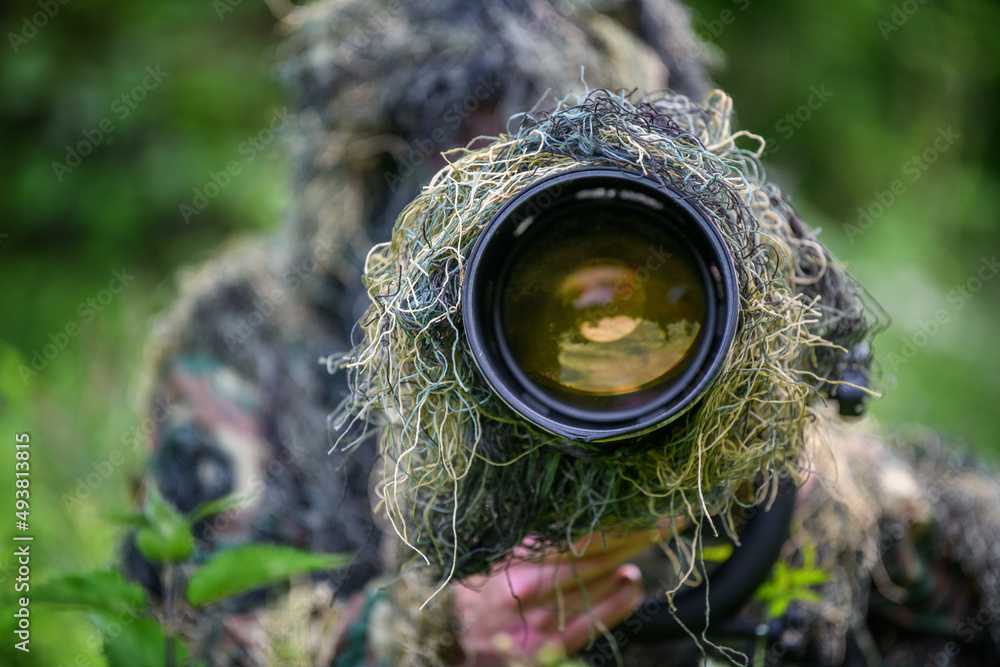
124;248;382;664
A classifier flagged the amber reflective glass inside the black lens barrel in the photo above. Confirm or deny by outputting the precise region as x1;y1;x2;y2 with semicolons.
503;209;706;408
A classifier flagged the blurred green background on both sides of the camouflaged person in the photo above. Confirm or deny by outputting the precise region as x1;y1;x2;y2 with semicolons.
0;0;1000;665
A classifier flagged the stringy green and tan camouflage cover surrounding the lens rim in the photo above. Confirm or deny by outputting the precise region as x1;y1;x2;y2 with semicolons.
340;91;878;579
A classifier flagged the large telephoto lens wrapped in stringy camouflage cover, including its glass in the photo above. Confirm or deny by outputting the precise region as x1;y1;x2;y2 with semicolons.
346;91;879;588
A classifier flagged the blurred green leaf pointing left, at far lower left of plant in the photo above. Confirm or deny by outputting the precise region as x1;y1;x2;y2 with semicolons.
31;571;146;613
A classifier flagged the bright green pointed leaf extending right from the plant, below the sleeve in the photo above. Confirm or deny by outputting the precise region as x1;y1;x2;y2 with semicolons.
186;544;351;607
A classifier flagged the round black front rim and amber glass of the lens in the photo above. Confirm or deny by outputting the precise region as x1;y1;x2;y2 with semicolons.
462;167;739;442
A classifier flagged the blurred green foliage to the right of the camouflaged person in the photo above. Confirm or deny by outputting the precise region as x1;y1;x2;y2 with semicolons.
693;0;1000;455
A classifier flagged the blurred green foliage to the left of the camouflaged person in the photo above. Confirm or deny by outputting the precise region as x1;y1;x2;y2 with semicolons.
0;0;289;665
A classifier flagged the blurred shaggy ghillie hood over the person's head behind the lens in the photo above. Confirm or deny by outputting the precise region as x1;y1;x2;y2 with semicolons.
281;0;710;322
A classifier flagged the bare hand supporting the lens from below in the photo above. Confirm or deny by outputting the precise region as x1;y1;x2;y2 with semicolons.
455;529;670;667
